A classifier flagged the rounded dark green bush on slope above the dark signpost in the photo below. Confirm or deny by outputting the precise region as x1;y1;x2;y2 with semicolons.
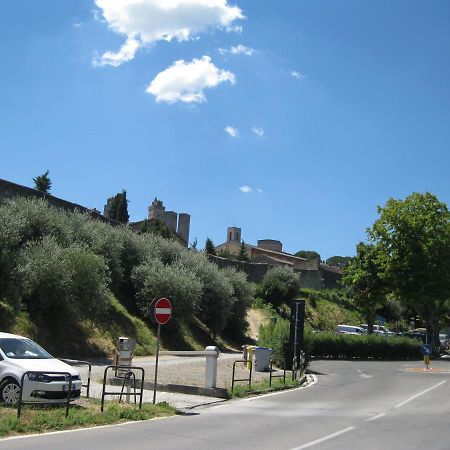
258;266;300;306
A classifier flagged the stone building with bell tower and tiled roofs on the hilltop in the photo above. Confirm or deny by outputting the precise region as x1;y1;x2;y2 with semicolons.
216;227;342;289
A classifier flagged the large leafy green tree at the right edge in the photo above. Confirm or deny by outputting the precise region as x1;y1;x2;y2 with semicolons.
368;192;450;346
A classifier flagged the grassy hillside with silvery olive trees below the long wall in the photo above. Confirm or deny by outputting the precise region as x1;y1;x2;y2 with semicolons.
0;198;254;357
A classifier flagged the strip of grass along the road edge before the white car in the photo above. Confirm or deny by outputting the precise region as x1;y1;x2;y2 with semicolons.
0;399;176;437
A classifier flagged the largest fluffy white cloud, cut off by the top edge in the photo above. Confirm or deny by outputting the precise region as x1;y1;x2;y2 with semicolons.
95;0;244;66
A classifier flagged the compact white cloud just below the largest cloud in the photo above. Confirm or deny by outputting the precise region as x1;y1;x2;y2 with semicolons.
146;56;236;103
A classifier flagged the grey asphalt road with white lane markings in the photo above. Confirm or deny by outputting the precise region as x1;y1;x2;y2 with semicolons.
0;361;450;450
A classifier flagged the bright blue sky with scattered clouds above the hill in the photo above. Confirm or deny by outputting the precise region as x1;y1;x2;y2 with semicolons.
0;0;450;258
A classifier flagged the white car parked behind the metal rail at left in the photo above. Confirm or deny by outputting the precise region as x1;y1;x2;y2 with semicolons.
0;333;81;405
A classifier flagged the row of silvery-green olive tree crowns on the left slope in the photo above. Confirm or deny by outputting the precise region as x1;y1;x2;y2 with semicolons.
0;199;253;344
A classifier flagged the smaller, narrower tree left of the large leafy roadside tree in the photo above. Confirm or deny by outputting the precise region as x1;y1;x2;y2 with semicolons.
342;242;385;334
